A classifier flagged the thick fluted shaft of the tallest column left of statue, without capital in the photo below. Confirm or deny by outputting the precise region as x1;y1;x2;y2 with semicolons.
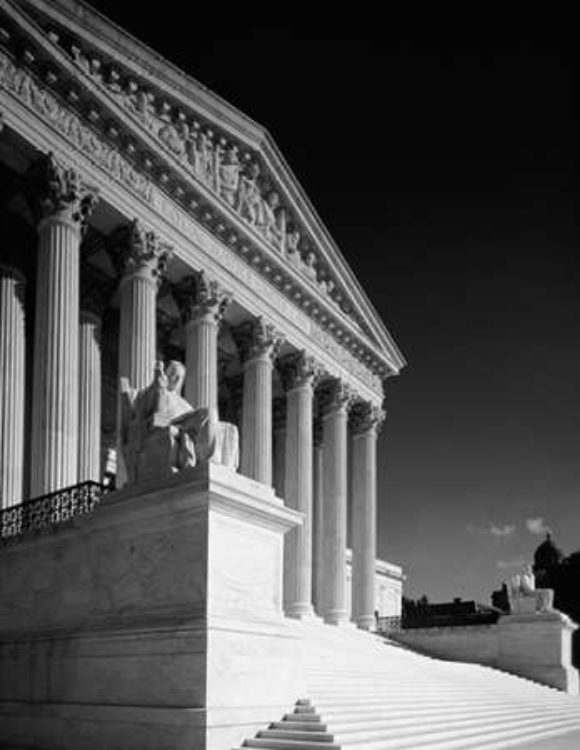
31;216;81;497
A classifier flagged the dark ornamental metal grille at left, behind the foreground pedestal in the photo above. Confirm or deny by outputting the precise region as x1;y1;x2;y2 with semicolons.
0;482;106;541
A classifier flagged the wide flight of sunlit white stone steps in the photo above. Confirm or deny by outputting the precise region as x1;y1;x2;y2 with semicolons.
231;625;580;750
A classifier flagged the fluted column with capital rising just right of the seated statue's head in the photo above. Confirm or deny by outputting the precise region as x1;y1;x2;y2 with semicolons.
174;271;231;415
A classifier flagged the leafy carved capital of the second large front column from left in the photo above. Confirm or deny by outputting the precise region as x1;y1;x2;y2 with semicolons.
109;219;172;284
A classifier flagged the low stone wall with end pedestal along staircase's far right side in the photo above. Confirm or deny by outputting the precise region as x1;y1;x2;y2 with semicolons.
391;612;578;695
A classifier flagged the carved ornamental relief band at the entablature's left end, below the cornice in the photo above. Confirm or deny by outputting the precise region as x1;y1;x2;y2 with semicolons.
0;52;151;200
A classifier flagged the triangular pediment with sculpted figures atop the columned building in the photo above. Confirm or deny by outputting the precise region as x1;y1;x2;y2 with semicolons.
0;0;405;377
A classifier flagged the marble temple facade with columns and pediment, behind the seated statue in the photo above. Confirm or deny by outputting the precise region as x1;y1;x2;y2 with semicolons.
0;0;405;748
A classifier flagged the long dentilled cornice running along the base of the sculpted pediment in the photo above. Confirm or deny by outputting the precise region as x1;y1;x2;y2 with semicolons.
0;0;400;394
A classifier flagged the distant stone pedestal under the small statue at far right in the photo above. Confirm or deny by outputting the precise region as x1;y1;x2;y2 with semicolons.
497;612;578;695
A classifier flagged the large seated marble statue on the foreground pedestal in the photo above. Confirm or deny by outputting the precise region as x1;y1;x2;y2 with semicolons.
120;361;238;482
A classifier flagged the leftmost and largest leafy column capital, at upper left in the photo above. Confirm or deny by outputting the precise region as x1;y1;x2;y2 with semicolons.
26;152;99;232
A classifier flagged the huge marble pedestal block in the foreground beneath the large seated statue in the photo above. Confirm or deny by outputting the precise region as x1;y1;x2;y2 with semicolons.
0;464;305;750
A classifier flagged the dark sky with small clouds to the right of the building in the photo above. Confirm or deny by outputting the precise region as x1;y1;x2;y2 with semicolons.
82;0;580;601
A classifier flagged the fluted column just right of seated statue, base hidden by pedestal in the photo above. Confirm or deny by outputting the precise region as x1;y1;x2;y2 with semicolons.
238;318;282;485
